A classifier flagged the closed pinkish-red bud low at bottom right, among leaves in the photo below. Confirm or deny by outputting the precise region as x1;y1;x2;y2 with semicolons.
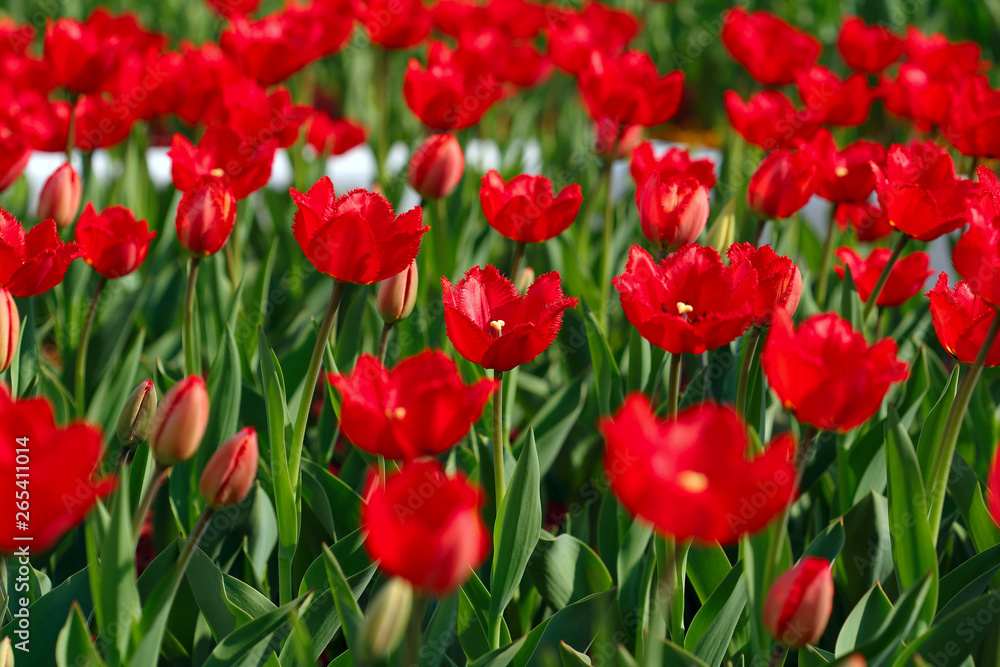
764;556;833;648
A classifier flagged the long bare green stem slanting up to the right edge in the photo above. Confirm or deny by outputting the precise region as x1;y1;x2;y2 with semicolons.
927;311;1000;543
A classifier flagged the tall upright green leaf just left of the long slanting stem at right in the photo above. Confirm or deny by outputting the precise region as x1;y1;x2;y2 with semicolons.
885;406;938;629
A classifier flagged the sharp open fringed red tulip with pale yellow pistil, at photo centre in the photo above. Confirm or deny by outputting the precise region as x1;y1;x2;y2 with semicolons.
441;265;579;372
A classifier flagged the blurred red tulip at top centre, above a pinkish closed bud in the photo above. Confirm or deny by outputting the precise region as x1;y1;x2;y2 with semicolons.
577;51;684;127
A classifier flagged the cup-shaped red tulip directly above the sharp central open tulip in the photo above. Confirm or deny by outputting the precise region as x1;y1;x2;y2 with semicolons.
479;169;583;243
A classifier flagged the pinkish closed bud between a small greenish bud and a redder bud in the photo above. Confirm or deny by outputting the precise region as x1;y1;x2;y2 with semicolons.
149;375;208;466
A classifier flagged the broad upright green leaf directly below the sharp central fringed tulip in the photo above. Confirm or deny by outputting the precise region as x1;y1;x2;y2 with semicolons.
490;431;542;619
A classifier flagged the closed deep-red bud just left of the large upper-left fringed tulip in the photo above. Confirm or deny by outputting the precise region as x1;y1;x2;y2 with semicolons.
174;175;236;257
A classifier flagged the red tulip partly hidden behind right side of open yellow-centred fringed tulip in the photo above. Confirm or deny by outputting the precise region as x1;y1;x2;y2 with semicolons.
726;243;802;327
